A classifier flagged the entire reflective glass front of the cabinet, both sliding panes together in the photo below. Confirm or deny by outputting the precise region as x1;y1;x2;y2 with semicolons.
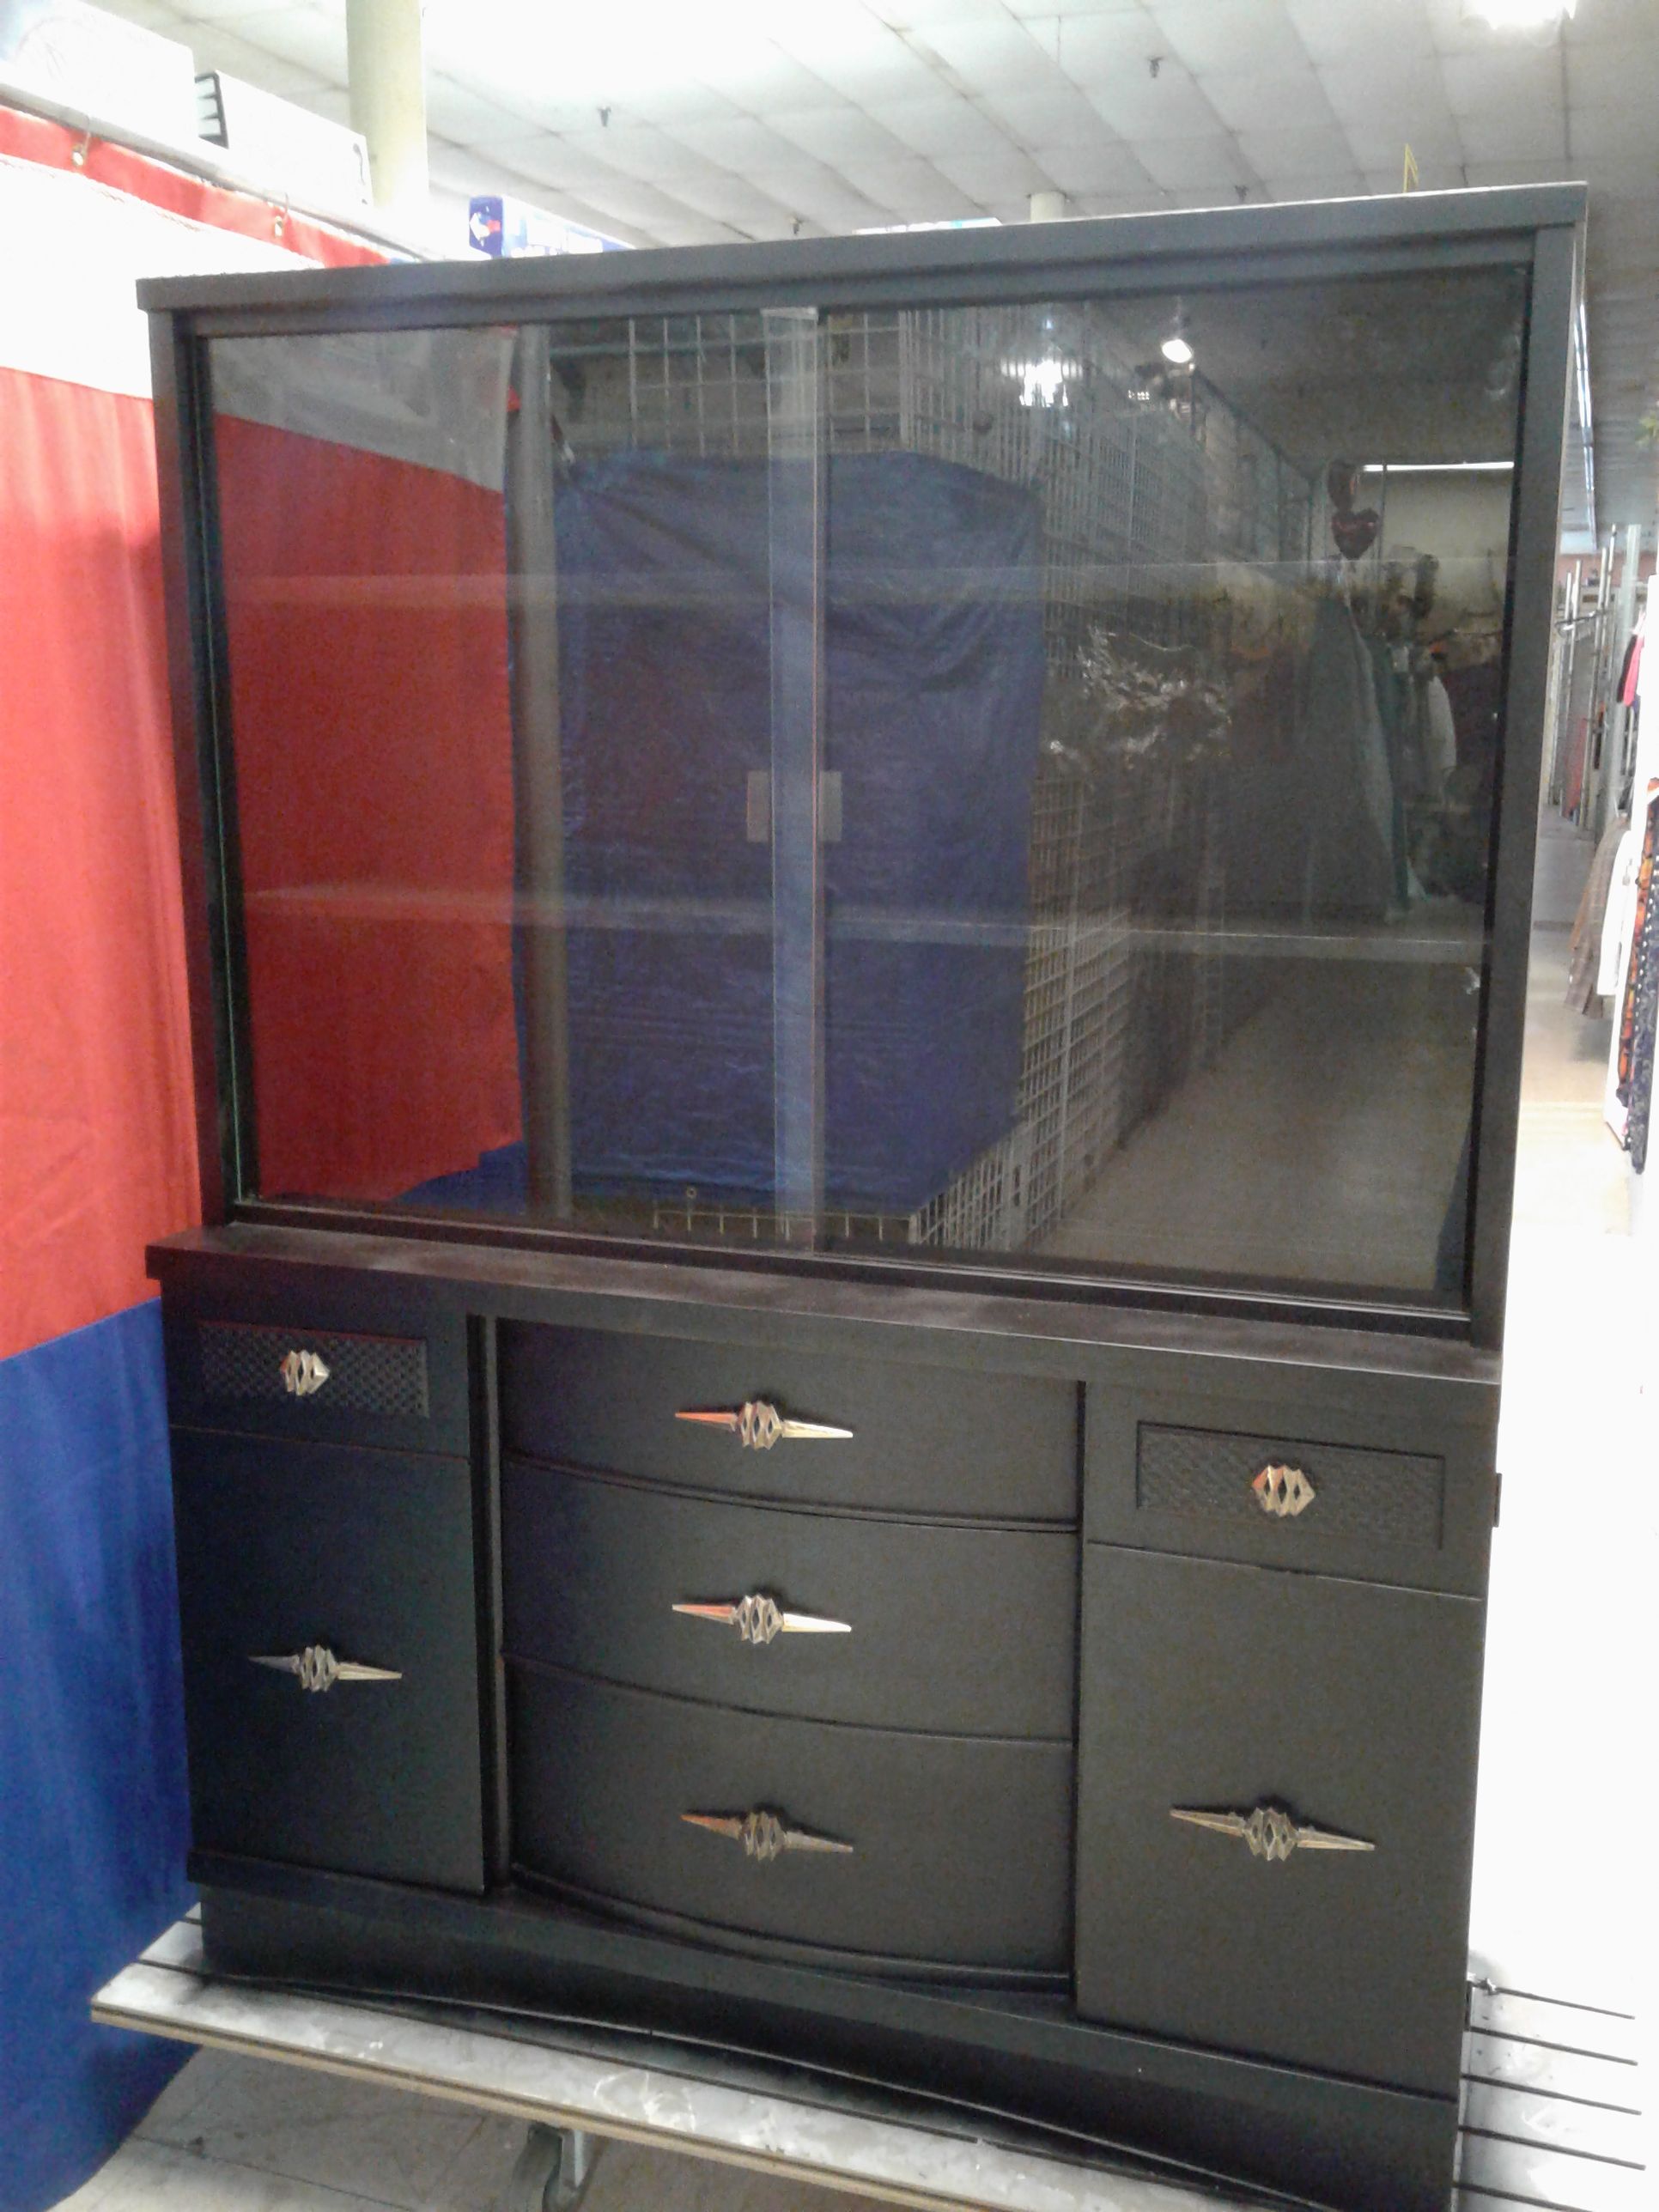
212;270;1524;1307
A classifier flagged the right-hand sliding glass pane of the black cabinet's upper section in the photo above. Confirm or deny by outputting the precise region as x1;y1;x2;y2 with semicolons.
825;270;1524;1305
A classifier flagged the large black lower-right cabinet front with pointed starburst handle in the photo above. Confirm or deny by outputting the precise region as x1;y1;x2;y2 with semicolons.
1078;1547;1482;2097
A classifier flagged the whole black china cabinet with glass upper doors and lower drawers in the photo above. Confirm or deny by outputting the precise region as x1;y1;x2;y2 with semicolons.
143;188;1582;2212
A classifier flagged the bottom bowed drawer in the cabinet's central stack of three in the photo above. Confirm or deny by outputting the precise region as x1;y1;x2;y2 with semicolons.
508;1666;1073;1975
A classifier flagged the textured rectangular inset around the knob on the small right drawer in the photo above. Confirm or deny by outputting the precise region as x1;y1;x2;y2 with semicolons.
1134;1422;1447;1551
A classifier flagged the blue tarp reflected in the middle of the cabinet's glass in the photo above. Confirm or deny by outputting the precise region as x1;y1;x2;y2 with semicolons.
556;453;1044;1212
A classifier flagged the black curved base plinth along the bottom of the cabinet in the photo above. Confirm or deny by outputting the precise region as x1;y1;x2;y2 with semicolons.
192;1856;1458;2212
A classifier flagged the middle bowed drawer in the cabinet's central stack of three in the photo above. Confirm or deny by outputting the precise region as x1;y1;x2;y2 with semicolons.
502;1460;1078;1741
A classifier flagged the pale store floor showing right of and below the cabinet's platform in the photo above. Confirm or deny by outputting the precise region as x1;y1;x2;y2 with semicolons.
52;830;1659;2212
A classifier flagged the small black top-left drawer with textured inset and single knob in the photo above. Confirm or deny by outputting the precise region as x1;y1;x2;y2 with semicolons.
164;1267;469;1453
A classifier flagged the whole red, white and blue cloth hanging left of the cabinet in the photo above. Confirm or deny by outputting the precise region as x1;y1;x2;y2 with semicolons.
0;108;380;2212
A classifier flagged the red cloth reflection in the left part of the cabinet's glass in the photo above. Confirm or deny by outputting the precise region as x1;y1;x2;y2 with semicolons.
216;418;520;1199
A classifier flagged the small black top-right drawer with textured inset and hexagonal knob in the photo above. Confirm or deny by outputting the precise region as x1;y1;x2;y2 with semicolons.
1086;1391;1495;1597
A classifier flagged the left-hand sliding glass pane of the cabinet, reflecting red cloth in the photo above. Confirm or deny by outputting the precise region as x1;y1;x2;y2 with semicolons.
212;314;821;1237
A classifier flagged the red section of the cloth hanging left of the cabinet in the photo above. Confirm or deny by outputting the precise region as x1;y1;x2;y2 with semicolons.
0;369;197;1356
